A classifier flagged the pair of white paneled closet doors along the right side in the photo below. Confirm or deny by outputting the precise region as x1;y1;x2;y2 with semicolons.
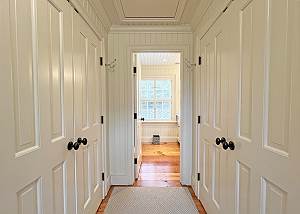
200;0;300;214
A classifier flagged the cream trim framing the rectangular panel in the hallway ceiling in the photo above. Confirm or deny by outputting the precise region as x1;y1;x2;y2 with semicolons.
114;0;186;22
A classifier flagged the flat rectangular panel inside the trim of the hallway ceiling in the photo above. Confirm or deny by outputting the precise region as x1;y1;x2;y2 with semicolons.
120;0;181;18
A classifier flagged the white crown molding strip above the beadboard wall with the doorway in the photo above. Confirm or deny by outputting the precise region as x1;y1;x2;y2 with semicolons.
109;24;192;33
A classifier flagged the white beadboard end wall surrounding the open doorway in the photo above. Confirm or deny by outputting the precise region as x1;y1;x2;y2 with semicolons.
108;28;193;184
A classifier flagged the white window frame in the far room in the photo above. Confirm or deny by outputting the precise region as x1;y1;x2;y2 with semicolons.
139;75;176;122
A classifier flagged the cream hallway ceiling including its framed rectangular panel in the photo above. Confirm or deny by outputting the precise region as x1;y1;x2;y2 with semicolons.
98;0;202;25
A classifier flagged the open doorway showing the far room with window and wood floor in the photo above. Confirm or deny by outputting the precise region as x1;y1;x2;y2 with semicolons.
133;52;181;187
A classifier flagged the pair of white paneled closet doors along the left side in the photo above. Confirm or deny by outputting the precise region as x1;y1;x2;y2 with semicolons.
0;0;105;214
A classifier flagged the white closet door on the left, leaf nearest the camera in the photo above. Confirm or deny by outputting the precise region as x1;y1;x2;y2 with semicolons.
0;0;75;214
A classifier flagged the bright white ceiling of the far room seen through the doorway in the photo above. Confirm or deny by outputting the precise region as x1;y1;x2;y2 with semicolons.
138;52;180;65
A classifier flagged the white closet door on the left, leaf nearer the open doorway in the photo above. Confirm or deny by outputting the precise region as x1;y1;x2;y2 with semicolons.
73;12;103;213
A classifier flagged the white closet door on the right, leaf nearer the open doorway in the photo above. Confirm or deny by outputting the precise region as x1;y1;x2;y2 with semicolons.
200;9;233;214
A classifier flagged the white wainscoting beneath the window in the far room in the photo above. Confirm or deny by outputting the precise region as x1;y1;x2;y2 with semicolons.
142;121;178;143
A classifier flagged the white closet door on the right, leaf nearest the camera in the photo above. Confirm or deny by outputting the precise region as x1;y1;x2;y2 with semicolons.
229;0;300;214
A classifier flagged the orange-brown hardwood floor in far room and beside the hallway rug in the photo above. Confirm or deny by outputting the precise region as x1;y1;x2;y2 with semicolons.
97;143;206;214
